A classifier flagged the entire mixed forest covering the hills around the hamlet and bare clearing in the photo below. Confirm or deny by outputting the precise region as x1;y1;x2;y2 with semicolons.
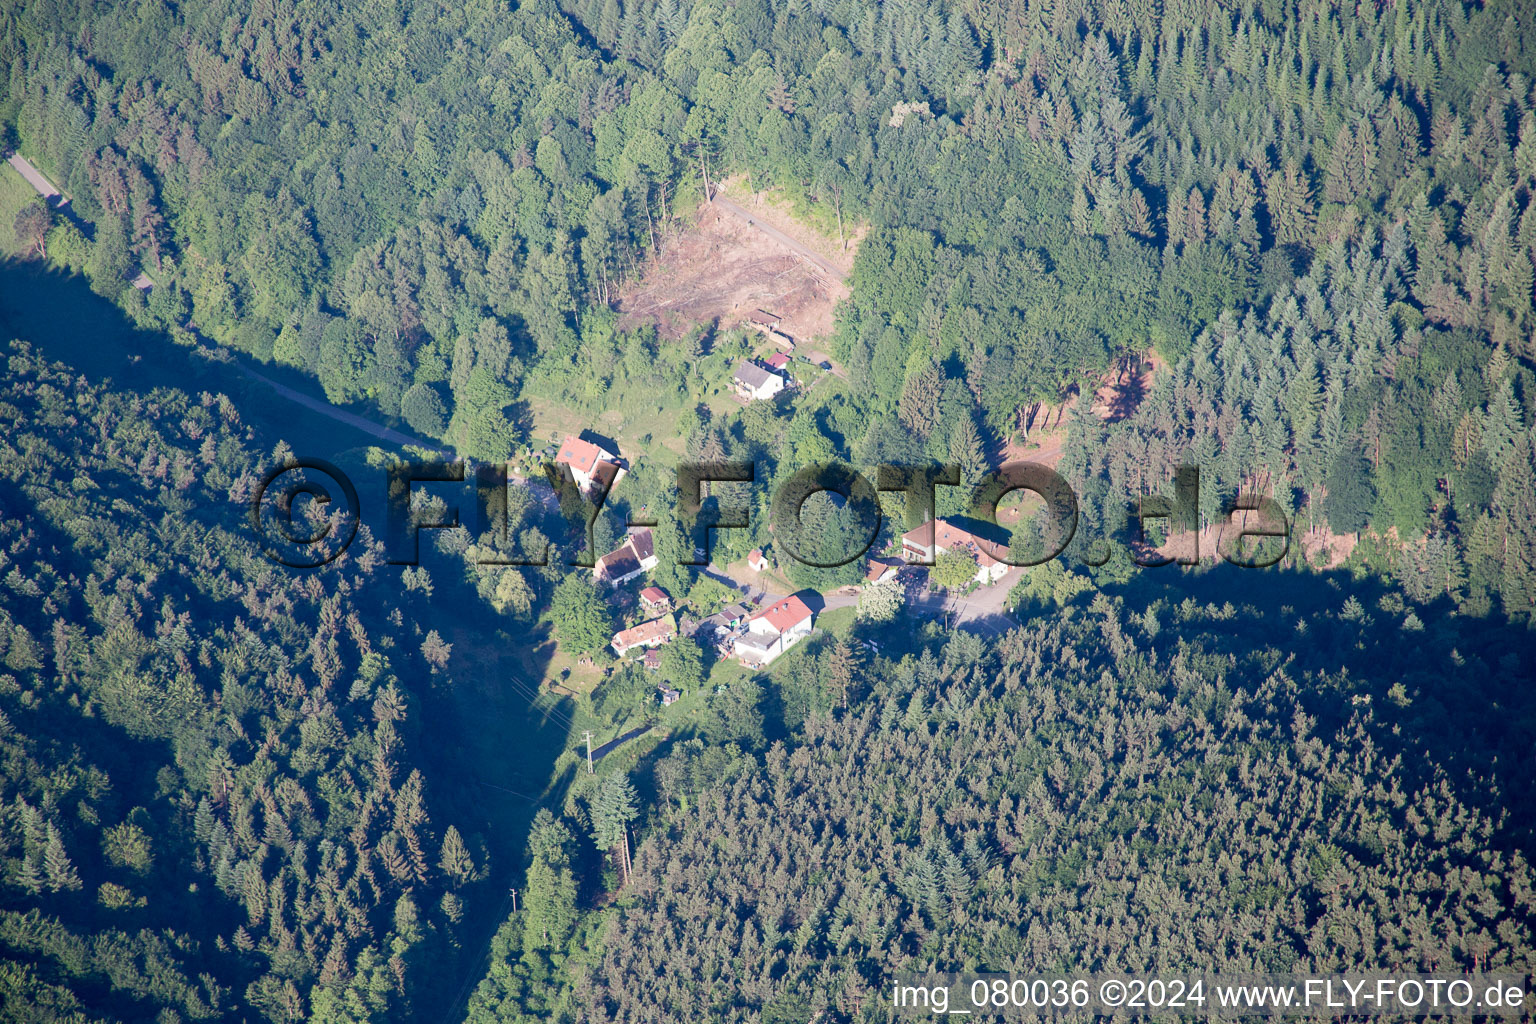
0;0;1536;1024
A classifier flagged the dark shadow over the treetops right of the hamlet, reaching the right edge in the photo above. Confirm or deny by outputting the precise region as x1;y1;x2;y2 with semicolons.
1007;563;1536;852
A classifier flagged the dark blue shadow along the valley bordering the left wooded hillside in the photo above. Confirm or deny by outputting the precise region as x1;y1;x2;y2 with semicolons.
0;251;573;1018
